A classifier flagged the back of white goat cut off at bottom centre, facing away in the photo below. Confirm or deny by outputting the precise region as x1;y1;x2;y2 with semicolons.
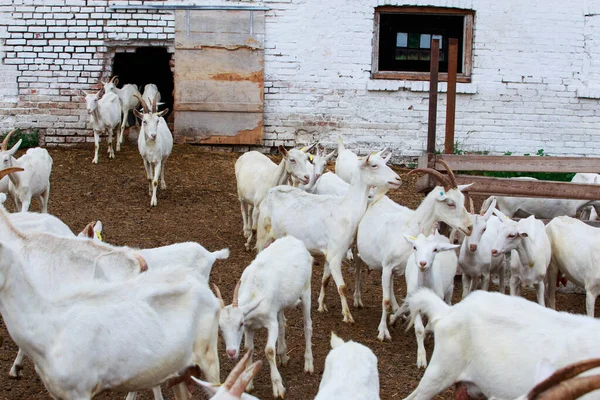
315;332;379;400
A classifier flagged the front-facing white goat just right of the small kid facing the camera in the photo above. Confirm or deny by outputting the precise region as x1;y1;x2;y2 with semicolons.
458;199;507;299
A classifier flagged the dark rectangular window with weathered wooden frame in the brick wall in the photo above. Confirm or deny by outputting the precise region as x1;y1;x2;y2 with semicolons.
371;6;474;82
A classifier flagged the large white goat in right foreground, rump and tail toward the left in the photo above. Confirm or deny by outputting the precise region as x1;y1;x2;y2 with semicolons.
403;288;600;400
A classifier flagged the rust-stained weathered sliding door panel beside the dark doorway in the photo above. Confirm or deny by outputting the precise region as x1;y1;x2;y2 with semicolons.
173;10;265;144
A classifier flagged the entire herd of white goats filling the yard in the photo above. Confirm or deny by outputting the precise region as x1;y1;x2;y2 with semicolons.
0;78;600;400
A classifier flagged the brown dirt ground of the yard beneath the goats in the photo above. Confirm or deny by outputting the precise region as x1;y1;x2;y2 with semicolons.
0;142;585;400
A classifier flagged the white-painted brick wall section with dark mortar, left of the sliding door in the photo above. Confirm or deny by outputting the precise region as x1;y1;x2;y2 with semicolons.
0;0;175;145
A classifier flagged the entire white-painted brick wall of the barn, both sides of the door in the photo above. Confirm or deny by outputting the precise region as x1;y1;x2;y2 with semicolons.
0;0;600;156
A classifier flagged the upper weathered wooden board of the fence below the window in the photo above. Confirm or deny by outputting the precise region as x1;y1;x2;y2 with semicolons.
435;154;600;173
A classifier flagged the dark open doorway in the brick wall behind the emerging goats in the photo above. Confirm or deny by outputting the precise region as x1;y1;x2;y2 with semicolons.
113;47;173;119
